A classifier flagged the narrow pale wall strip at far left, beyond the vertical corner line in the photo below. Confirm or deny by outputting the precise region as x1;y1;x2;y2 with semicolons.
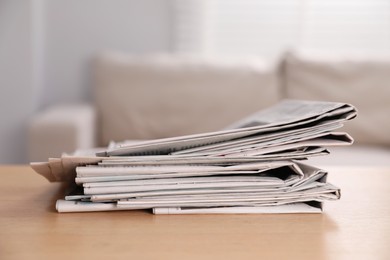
0;0;34;163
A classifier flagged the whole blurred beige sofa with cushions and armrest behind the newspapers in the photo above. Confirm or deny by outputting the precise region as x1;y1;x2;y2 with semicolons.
29;53;390;165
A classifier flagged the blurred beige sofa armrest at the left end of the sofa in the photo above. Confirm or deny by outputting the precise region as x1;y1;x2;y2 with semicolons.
28;105;97;161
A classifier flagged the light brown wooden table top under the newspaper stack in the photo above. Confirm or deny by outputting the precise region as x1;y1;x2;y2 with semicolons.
0;166;390;260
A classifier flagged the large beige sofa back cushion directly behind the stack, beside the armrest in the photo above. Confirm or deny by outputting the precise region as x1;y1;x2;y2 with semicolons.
95;53;280;145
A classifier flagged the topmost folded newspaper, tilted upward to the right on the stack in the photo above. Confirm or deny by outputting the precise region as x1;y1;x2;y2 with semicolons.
97;100;357;156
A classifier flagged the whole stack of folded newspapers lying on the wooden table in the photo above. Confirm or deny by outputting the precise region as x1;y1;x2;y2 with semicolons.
31;100;357;214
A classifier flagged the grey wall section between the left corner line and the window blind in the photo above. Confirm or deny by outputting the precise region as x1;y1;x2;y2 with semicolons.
43;0;171;106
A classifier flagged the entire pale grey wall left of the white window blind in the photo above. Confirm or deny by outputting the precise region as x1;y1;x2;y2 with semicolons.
0;0;172;163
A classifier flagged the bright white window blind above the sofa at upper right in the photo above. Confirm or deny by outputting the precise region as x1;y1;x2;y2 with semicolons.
174;0;390;59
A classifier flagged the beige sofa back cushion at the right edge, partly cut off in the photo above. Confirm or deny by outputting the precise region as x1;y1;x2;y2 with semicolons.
282;53;390;146
